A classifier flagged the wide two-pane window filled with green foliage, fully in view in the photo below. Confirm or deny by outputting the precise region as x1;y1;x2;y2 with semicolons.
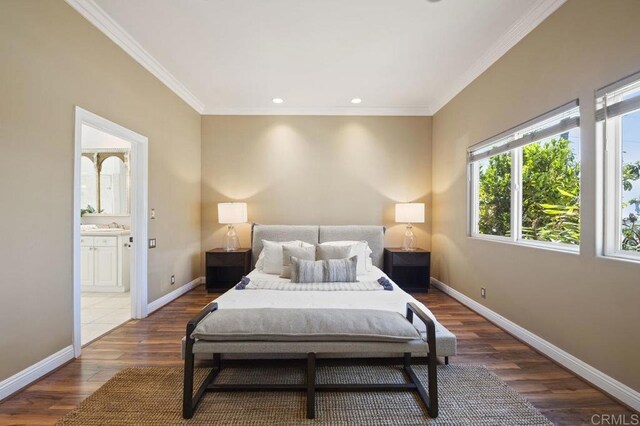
468;101;580;250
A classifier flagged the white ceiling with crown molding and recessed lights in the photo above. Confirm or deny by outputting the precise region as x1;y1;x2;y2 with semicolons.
67;0;564;115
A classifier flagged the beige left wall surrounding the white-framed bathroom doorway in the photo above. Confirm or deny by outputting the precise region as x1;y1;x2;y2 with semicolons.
0;0;200;381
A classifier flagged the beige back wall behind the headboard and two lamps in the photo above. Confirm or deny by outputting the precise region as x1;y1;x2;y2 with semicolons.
202;116;431;256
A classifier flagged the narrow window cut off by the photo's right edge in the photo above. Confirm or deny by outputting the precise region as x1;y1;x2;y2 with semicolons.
596;73;640;259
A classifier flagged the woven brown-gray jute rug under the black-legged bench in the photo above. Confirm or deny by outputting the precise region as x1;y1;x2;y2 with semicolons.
58;365;551;426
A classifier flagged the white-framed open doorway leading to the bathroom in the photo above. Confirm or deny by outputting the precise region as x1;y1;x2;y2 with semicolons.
73;107;148;357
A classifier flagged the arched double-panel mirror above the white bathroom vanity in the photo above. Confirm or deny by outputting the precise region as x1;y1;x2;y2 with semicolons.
80;151;129;216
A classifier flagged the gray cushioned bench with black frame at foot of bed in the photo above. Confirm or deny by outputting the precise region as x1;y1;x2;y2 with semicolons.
183;303;438;419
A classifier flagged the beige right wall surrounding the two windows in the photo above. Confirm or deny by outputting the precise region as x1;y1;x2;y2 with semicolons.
433;0;640;390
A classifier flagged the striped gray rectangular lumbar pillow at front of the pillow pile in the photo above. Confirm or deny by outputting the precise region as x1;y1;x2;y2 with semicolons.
291;256;358;283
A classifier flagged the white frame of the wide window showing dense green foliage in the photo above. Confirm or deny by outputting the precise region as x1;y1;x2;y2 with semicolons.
467;99;582;254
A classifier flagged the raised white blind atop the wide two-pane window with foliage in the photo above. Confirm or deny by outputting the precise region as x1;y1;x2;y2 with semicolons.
467;99;580;163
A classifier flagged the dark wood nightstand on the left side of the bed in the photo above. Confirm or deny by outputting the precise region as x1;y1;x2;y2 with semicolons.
206;248;251;293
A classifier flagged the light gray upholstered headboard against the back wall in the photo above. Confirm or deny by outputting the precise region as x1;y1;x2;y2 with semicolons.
251;224;385;269
